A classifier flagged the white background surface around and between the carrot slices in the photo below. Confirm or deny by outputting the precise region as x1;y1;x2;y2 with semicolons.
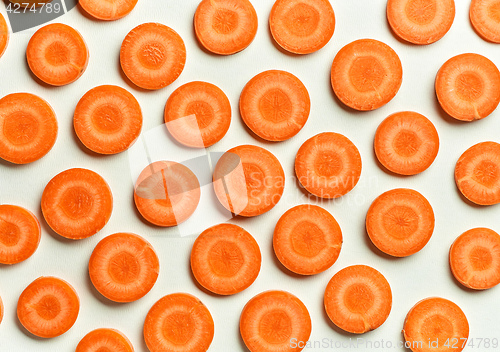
0;0;500;352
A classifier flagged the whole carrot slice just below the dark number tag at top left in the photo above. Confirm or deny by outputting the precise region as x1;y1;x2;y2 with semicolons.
26;23;89;86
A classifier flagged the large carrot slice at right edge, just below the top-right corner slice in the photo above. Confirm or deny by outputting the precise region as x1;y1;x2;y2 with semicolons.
436;54;500;121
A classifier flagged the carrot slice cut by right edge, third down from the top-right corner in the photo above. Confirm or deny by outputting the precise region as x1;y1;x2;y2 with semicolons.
455;142;500;205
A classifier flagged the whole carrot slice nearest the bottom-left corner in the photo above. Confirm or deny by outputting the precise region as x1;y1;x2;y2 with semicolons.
17;276;80;338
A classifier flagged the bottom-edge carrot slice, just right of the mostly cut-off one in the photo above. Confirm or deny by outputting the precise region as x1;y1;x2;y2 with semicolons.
144;293;214;352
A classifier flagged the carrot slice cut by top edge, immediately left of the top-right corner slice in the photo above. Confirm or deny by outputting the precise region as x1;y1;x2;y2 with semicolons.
387;0;455;45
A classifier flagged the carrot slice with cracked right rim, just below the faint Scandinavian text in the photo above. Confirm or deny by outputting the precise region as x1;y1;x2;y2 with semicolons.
273;204;342;275
